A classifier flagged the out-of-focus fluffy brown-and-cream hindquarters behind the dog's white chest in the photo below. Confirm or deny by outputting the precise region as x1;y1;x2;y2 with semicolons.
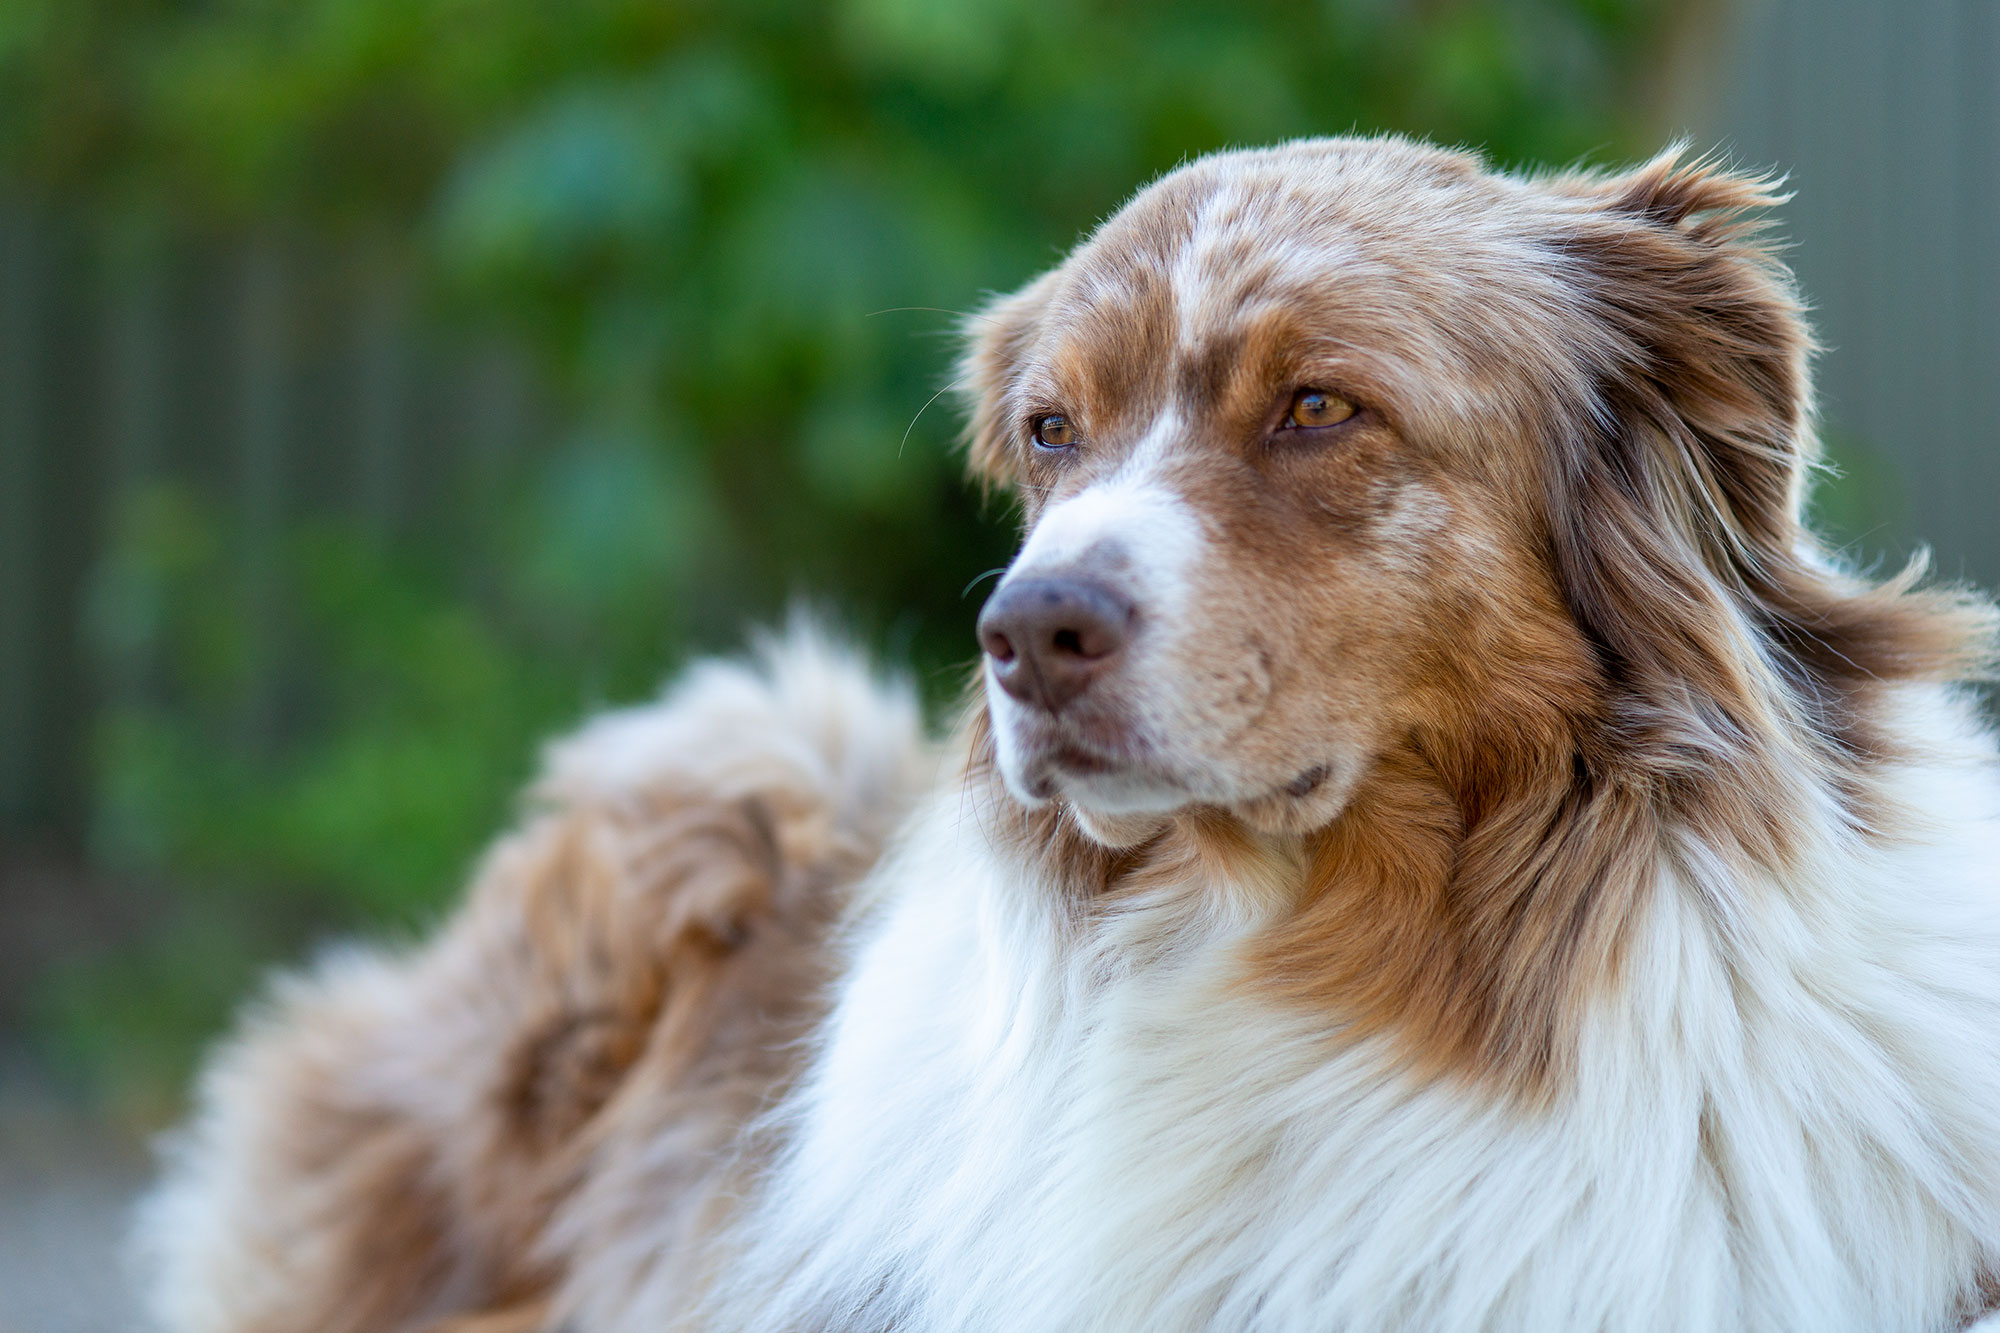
138;624;936;1333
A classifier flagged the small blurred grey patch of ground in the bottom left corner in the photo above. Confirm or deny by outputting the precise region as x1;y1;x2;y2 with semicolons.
0;1055;148;1333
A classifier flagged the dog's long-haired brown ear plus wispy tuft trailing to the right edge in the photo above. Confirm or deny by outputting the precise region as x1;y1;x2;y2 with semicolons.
1548;148;1992;780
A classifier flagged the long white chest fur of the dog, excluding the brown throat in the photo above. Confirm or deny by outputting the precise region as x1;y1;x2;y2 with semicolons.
728;688;2000;1333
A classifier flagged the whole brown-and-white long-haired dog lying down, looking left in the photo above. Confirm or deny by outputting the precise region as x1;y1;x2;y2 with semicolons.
142;138;2000;1333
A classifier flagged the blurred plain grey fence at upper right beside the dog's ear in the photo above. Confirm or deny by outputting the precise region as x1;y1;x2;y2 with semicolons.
1676;0;2000;586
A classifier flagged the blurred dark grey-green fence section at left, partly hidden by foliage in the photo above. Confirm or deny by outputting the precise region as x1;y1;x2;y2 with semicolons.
0;200;540;845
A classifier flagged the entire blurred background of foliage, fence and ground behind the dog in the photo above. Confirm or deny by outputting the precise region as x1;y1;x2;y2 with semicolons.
0;0;2000;1333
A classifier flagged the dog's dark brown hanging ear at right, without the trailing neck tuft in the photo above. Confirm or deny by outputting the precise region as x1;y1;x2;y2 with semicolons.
1546;148;1814;713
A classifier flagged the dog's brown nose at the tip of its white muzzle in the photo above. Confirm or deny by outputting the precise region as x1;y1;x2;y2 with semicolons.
980;578;1132;713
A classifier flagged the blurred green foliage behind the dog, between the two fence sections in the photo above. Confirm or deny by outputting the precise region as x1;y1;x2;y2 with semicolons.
0;0;1672;1112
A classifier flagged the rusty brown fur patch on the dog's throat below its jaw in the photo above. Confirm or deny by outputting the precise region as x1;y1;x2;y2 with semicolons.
960;600;1898;1103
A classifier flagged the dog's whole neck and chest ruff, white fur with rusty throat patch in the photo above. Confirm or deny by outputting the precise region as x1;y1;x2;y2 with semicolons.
726;664;2000;1329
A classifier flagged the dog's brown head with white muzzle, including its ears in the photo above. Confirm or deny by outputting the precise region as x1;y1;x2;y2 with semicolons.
962;138;1984;845
